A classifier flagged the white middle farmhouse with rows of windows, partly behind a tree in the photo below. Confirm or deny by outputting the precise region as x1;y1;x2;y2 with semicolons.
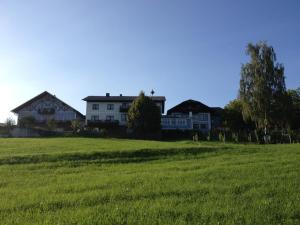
83;93;166;126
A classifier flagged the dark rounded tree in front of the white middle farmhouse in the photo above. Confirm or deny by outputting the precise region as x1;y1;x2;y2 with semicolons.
128;92;161;135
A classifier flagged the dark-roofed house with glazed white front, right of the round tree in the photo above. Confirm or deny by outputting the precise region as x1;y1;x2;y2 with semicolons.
161;99;222;132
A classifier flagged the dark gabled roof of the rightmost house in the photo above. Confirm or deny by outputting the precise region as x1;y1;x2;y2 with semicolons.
167;99;213;115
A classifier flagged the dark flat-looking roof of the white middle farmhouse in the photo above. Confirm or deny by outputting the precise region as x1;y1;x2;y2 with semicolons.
82;96;166;102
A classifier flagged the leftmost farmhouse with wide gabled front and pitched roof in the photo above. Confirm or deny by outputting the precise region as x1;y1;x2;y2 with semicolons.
12;91;84;123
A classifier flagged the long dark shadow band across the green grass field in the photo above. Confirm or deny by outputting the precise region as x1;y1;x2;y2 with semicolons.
0;147;227;165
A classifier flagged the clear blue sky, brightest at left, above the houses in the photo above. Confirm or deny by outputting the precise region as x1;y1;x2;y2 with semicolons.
0;0;300;121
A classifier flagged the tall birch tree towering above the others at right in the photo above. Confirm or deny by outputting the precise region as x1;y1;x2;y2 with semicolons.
239;42;287;130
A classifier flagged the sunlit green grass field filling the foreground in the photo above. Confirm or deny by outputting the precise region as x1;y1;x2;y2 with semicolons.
0;138;300;225
